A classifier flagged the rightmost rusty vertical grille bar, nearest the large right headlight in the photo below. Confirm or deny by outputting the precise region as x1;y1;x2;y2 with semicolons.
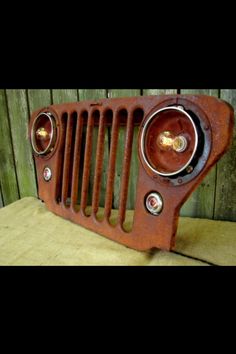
118;113;134;225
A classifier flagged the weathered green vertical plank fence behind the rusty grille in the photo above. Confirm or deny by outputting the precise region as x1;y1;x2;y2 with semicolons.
0;89;236;221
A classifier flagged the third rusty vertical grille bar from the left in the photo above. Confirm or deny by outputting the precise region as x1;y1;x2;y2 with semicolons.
80;110;97;215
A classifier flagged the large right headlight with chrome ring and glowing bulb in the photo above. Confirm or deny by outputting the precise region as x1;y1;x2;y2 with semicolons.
141;106;198;176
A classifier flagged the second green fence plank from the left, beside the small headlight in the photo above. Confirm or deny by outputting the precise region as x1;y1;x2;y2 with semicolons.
6;90;37;198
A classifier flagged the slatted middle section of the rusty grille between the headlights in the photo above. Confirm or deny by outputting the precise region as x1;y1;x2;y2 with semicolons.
53;104;144;232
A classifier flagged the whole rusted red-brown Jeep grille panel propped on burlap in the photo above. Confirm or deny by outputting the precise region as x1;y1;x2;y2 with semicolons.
29;95;233;250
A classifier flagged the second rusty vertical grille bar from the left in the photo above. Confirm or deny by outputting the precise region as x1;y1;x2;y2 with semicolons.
71;111;88;211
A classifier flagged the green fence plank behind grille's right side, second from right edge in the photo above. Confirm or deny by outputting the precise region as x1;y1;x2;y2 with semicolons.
180;90;218;219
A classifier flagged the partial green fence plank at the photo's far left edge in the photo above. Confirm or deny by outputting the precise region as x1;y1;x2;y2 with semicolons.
0;90;19;205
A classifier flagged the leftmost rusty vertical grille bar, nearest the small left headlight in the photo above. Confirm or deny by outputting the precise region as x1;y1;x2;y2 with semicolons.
61;112;77;206
